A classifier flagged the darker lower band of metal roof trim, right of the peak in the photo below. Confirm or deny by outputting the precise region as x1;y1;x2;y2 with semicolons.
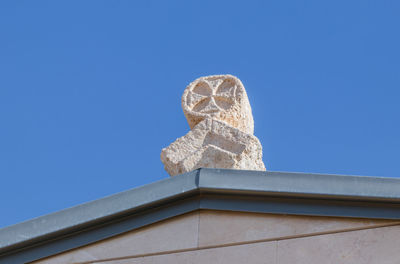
200;195;400;220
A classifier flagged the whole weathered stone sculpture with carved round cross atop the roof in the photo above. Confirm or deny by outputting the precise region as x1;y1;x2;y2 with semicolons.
161;75;265;176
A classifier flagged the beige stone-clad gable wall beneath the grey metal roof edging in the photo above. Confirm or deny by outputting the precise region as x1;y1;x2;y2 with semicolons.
34;210;400;264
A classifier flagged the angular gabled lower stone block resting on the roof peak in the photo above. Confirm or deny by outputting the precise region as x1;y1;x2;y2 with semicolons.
161;118;265;176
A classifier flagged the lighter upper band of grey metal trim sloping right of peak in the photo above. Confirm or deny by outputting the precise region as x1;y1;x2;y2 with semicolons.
199;169;400;202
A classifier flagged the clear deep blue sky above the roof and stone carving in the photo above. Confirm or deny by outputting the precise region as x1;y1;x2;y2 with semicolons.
0;0;400;227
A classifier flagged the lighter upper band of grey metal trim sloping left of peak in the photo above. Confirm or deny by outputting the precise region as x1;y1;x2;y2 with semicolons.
0;171;199;254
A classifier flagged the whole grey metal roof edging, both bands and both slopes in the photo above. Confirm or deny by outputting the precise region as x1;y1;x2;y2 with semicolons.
0;169;400;263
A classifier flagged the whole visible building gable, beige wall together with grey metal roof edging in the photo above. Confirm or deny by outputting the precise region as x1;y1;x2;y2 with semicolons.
0;169;400;264
